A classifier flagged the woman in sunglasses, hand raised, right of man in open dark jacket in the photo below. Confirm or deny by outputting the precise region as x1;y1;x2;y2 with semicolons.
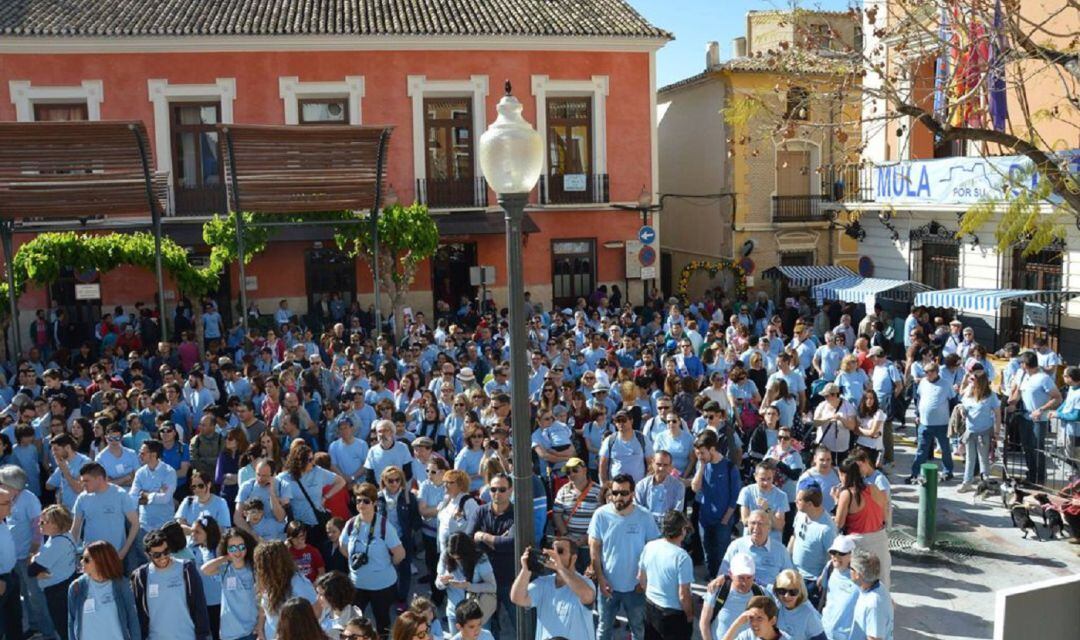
200;527;259;640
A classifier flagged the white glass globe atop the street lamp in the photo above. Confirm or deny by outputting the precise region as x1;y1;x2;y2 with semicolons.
480;82;543;194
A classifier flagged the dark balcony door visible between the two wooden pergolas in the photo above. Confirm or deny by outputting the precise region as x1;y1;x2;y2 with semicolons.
170;103;226;215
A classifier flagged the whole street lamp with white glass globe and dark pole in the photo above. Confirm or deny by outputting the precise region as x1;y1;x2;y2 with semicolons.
480;80;543;640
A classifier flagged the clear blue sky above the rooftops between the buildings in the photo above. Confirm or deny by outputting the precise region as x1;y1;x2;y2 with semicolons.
627;0;850;86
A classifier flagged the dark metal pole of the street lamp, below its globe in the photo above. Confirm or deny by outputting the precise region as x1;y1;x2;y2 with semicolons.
499;193;534;640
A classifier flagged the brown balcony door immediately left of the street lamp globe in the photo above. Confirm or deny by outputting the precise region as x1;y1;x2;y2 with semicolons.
419;97;477;208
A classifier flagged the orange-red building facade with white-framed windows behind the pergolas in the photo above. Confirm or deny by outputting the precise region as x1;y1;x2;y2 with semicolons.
0;4;669;332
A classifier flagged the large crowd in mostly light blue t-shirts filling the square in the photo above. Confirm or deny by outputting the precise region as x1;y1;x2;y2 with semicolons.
0;288;1080;640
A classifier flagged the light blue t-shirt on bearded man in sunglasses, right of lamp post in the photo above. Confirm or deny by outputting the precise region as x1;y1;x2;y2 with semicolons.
589;504;660;593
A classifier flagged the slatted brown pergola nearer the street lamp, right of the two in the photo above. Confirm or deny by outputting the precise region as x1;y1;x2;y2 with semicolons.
218;124;392;333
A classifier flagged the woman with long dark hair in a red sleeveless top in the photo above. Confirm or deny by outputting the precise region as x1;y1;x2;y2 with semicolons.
836;458;891;587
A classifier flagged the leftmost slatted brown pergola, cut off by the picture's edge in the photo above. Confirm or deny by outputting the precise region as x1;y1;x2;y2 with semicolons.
0;122;165;354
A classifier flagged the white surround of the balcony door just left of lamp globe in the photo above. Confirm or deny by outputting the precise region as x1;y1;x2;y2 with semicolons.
406;76;488;200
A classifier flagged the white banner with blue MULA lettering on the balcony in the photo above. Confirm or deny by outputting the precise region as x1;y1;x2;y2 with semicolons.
872;151;1080;205
